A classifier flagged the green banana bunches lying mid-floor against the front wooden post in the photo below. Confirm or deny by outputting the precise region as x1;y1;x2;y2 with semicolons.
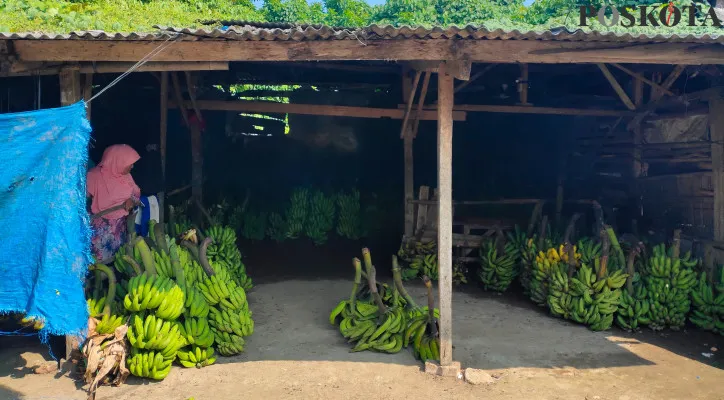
329;248;440;362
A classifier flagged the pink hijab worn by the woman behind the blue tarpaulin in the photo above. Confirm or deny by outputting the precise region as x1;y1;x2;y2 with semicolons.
86;144;141;220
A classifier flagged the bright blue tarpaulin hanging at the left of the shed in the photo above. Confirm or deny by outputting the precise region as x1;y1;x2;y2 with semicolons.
0;102;92;336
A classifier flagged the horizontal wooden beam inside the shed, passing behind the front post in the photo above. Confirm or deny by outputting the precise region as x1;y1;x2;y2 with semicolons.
169;100;465;121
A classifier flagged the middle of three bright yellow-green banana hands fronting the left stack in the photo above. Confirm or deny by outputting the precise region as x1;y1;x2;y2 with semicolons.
126;314;186;357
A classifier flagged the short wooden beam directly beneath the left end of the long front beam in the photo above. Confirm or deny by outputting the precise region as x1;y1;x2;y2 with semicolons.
5;61;229;76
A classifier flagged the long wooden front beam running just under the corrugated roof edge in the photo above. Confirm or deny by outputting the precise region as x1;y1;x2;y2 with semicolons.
11;39;724;65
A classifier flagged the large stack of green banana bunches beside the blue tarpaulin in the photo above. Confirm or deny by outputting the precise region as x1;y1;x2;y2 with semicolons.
88;223;254;380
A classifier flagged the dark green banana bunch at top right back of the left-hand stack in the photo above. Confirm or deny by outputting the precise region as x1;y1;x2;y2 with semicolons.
206;226;254;290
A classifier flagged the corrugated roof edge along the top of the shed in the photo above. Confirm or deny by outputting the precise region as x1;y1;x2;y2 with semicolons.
0;21;724;43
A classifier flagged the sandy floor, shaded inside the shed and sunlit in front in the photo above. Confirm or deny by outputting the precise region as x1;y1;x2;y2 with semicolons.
0;280;724;400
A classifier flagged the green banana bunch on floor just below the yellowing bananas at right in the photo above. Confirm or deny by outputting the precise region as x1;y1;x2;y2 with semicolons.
557;266;628;331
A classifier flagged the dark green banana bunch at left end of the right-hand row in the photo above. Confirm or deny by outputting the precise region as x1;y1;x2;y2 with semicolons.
478;235;520;292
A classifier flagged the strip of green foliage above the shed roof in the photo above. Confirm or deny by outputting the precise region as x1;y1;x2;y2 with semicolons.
0;0;720;34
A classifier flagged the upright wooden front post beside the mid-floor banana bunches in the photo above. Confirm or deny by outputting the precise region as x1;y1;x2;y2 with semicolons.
437;63;454;367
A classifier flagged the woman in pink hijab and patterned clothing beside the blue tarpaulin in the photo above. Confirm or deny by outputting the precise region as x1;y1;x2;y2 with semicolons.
87;144;141;263
